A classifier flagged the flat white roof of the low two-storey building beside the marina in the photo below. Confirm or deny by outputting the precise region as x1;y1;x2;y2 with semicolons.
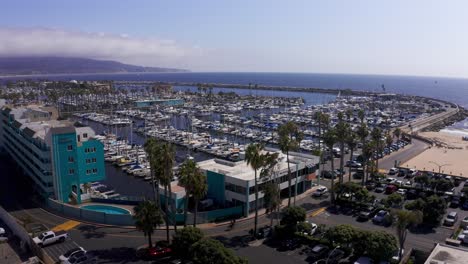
198;148;319;181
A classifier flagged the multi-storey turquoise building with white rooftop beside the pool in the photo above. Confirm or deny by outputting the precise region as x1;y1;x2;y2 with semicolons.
0;106;105;203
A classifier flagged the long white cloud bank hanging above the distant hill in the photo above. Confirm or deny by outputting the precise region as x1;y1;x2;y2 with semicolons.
0;27;198;67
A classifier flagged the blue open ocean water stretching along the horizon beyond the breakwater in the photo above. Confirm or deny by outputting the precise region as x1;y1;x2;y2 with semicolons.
3;72;468;107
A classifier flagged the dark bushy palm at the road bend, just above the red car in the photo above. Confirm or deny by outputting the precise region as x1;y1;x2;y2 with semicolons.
133;200;163;247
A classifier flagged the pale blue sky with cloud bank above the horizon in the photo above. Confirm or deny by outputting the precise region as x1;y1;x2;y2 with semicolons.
0;0;468;78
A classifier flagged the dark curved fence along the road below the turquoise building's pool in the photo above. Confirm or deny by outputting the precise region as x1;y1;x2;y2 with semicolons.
47;199;135;226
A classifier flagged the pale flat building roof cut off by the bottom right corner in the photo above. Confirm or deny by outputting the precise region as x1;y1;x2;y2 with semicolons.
424;244;468;264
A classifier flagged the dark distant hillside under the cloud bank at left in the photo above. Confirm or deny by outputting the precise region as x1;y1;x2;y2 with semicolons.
0;57;187;75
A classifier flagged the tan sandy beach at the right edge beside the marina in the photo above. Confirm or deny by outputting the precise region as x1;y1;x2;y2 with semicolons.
401;131;468;178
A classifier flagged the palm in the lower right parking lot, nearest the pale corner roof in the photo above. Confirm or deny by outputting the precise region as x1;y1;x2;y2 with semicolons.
392;210;423;260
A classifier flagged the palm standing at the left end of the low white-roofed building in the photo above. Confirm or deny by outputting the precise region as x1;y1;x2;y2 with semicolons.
179;159;205;227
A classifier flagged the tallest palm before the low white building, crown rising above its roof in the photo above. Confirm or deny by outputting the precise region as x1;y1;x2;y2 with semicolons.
278;121;303;207
